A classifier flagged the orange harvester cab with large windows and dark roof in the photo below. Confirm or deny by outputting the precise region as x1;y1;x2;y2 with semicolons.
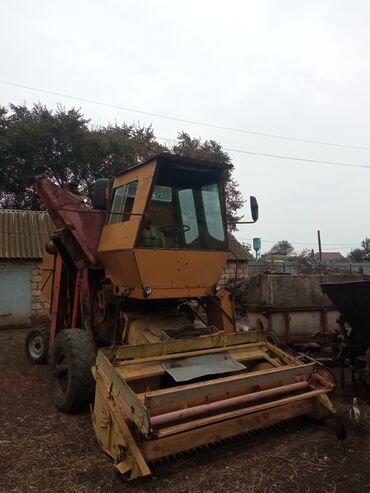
98;157;228;300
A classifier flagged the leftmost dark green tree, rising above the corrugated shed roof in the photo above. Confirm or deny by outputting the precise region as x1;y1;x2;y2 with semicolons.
0;104;87;209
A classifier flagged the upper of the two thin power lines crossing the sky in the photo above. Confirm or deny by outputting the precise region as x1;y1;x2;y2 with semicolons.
0;80;370;151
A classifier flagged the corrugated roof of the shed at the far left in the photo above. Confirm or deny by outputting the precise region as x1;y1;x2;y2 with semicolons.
0;209;55;259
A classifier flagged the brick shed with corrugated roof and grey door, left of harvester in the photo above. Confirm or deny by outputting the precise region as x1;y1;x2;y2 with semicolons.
0;209;53;327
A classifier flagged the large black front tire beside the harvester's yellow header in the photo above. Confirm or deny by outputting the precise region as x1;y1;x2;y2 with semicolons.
50;329;96;414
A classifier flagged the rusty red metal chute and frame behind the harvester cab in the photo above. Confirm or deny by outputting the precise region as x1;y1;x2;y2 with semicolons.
34;178;106;348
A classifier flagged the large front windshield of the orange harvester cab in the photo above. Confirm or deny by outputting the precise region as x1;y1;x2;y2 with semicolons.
139;166;227;250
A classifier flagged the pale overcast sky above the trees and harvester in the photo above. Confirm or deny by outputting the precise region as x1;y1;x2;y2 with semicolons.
0;0;370;254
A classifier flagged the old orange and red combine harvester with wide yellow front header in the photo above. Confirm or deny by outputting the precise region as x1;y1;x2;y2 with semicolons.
28;155;334;479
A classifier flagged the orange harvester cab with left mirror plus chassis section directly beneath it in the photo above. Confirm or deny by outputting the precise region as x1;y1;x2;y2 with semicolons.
93;155;249;344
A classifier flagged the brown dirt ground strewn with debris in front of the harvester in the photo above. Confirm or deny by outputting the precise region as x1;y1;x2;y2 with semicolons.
0;329;370;493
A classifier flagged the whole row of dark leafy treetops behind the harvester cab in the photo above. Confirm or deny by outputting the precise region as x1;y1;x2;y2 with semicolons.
0;104;243;225
